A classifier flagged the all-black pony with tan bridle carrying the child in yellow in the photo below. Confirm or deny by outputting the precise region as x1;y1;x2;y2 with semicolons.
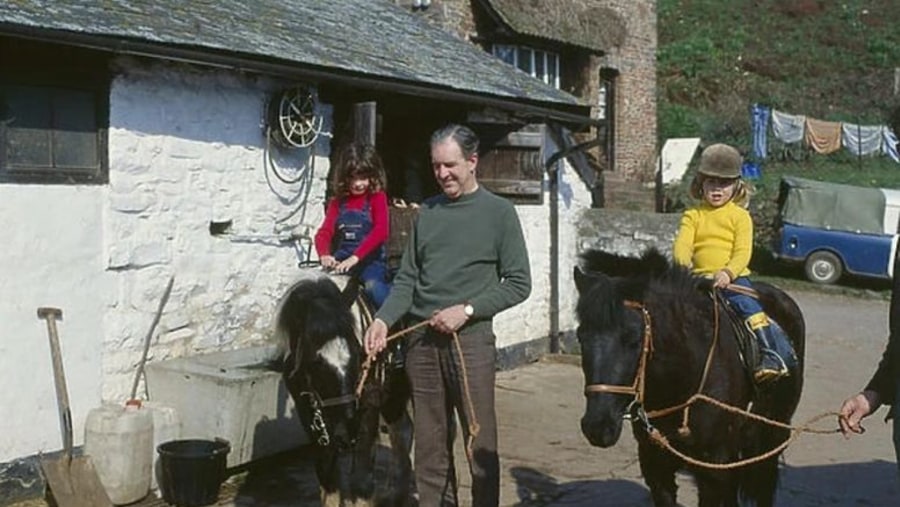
575;250;805;507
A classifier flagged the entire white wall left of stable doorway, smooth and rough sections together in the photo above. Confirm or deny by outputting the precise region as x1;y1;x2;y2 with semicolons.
0;60;331;462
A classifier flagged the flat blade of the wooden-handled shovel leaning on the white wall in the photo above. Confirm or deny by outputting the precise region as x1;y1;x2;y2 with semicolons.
41;456;113;507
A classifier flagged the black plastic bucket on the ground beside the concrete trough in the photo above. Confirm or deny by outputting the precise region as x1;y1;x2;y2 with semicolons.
156;439;231;507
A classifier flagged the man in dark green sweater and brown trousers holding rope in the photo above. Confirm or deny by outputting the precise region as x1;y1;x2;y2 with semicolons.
365;125;531;507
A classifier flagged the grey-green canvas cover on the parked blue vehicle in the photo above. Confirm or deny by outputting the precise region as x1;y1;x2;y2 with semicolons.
779;176;888;234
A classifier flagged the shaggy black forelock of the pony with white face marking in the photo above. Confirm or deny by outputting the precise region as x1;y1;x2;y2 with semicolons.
276;277;356;362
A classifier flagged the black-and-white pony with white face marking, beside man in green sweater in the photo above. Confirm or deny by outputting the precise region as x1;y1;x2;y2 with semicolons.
276;275;412;507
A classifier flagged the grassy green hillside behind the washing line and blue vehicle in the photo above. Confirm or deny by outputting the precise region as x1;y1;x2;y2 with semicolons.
657;0;900;282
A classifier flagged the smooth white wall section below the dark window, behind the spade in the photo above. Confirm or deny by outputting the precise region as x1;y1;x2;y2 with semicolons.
0;189;112;462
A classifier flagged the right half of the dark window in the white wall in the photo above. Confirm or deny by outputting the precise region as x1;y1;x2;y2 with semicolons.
53;90;99;169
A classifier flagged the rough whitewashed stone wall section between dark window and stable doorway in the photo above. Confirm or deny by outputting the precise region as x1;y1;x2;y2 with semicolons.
102;61;330;400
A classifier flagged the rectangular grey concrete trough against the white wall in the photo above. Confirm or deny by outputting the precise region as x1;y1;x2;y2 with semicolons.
146;346;309;467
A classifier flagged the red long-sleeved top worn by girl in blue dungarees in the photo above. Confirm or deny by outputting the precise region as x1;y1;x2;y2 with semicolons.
315;191;389;259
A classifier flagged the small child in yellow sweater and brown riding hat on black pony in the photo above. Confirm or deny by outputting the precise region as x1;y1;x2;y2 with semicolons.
672;144;797;384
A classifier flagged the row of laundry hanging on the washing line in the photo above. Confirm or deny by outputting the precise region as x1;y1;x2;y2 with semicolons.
750;104;900;163
